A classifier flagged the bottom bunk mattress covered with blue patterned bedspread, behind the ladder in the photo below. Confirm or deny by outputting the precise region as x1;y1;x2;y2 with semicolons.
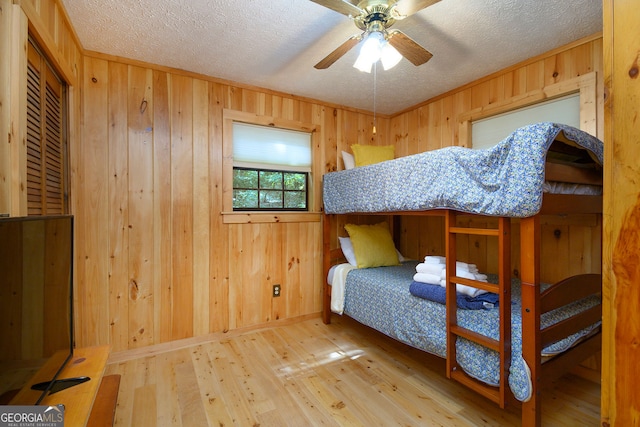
332;261;600;401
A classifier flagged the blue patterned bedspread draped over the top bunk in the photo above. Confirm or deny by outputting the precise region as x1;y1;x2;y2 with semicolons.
323;122;603;218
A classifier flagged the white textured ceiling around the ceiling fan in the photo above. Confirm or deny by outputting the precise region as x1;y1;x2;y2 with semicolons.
62;0;602;114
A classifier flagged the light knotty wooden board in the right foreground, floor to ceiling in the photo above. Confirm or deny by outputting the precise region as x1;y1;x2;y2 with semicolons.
601;0;640;426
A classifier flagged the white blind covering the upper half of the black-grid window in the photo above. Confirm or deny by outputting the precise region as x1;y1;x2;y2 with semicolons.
233;122;311;172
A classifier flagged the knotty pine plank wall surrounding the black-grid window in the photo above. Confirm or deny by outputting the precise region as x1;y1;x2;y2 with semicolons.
73;53;388;351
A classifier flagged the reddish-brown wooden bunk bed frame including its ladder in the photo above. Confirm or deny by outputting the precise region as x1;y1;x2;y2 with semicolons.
322;162;602;426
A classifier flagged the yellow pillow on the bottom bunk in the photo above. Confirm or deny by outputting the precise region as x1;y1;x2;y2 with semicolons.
344;222;400;268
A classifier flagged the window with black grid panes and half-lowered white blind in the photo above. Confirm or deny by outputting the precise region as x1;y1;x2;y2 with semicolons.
233;122;311;211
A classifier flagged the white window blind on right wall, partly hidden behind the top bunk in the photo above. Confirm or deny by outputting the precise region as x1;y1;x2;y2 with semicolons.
471;93;580;148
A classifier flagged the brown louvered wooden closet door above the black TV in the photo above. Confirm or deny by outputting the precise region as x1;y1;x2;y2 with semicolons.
27;41;67;215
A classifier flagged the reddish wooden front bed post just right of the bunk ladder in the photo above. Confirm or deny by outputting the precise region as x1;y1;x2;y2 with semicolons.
520;215;542;426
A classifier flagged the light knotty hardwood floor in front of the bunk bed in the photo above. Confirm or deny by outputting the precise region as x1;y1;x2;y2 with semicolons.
106;316;600;427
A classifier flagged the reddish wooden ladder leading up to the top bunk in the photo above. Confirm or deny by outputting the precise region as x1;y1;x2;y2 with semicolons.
445;210;511;408
